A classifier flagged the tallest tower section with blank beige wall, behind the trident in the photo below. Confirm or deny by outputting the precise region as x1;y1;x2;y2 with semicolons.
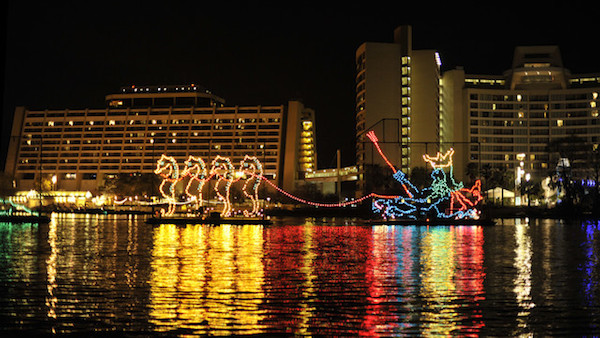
356;26;441;195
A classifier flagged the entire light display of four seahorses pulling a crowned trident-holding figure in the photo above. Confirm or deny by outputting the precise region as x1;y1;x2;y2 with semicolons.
154;131;483;219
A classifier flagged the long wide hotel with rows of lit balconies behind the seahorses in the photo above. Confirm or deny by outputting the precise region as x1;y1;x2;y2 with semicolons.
5;85;316;193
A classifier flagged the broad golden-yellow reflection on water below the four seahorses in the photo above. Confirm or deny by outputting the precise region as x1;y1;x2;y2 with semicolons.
149;224;264;335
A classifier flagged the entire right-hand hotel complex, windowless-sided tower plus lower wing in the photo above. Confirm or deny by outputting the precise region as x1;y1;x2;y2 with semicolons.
356;26;600;195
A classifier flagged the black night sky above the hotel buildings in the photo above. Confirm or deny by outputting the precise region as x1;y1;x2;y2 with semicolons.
0;0;600;168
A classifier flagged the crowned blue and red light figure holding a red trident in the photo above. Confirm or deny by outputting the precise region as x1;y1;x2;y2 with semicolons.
367;131;483;220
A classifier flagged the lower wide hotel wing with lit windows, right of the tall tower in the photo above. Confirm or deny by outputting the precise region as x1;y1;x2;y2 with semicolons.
441;46;600;179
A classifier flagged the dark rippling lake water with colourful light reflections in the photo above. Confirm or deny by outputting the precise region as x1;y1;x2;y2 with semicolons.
0;214;600;336
